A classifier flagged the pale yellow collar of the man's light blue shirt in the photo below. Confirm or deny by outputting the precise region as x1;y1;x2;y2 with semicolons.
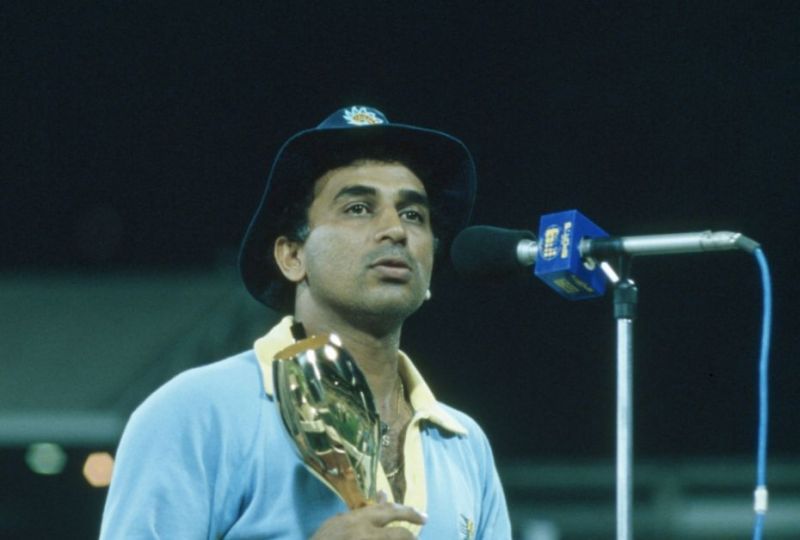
253;316;467;436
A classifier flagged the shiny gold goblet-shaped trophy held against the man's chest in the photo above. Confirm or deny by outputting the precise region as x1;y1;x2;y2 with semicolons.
272;323;381;509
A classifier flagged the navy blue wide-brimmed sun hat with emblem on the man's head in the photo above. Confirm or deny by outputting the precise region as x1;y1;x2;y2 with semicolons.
239;106;476;313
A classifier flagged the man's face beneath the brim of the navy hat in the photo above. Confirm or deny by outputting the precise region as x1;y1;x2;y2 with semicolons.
292;161;434;321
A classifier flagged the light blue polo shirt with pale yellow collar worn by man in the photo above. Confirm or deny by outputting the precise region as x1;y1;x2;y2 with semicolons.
100;317;511;540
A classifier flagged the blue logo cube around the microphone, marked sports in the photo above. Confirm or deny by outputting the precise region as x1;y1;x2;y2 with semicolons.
534;210;608;300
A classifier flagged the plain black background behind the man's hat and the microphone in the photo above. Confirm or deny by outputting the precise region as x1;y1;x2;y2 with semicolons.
0;1;800;536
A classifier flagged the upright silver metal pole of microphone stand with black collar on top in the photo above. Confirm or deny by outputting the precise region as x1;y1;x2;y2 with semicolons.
614;276;638;540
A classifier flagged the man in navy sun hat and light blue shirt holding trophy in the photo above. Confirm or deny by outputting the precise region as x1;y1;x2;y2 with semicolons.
101;107;511;540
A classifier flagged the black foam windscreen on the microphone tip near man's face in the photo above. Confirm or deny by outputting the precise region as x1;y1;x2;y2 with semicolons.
450;225;535;279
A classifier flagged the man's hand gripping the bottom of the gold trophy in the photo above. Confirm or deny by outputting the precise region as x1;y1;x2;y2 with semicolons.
311;492;428;540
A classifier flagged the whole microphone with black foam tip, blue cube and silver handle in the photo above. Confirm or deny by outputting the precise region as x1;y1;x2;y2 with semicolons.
450;210;759;300
